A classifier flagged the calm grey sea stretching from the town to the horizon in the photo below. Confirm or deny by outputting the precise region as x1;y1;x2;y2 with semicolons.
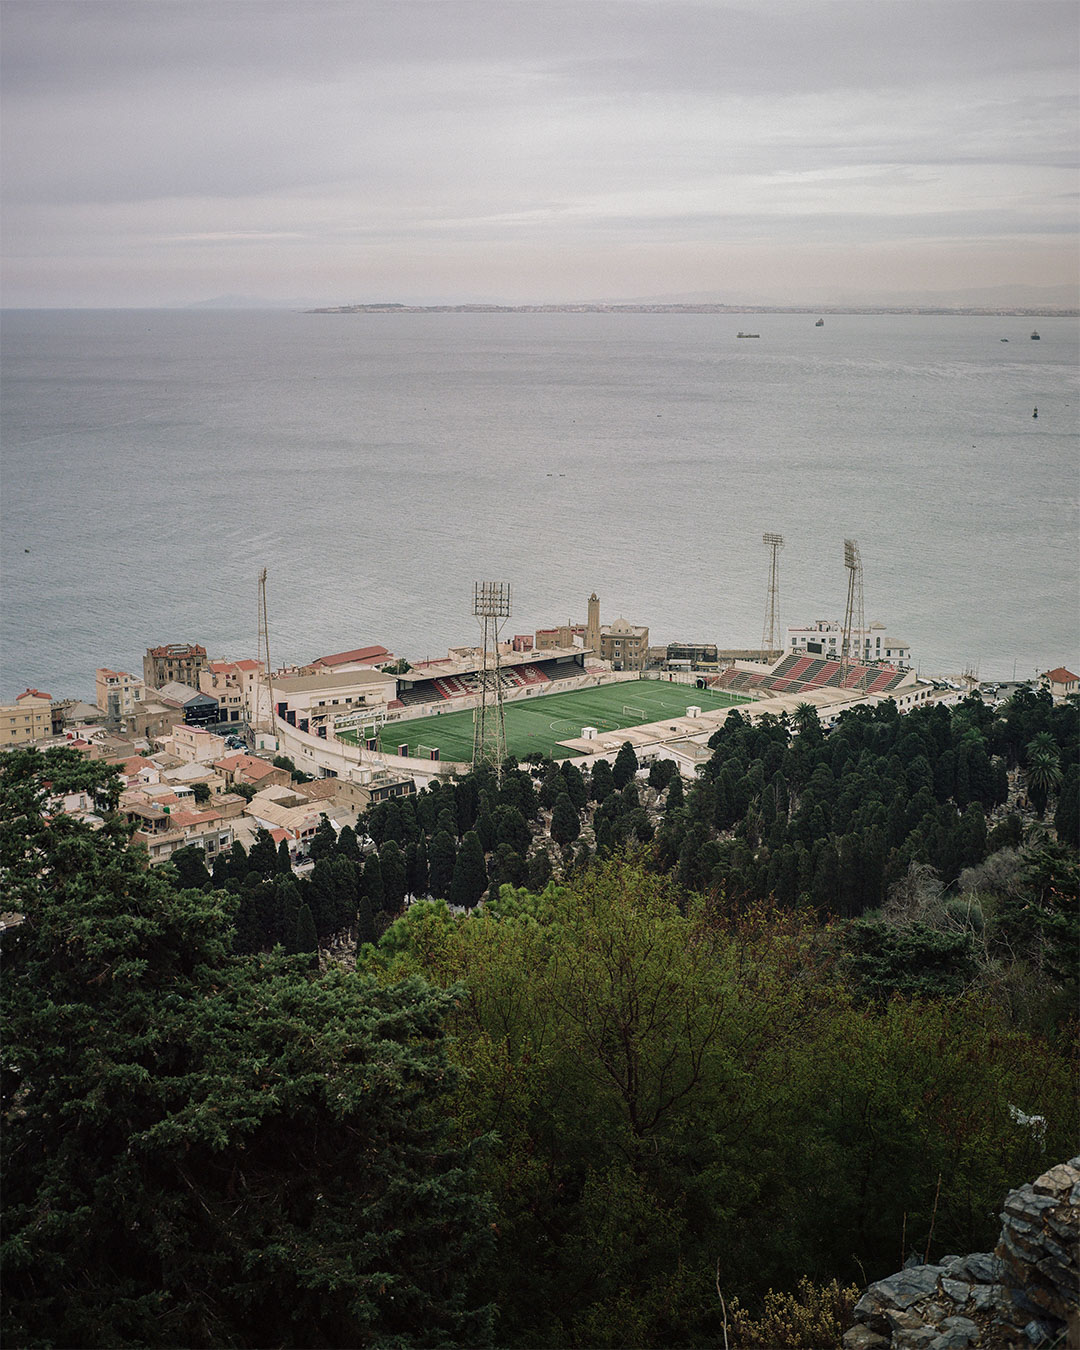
0;311;1080;699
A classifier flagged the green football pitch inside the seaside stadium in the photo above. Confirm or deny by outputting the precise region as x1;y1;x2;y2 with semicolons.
340;679;749;761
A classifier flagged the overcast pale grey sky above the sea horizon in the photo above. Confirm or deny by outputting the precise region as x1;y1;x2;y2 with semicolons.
0;0;1077;306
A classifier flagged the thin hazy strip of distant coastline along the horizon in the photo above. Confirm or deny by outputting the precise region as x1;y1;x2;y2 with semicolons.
304;302;1080;319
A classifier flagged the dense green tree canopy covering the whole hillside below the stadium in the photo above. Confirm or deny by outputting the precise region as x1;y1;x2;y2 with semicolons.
0;693;1080;1347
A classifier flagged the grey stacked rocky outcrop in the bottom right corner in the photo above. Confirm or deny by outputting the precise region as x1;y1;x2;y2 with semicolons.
844;1157;1080;1350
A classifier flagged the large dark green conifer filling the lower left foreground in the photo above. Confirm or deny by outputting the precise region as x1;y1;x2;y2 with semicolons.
0;749;490;1347
